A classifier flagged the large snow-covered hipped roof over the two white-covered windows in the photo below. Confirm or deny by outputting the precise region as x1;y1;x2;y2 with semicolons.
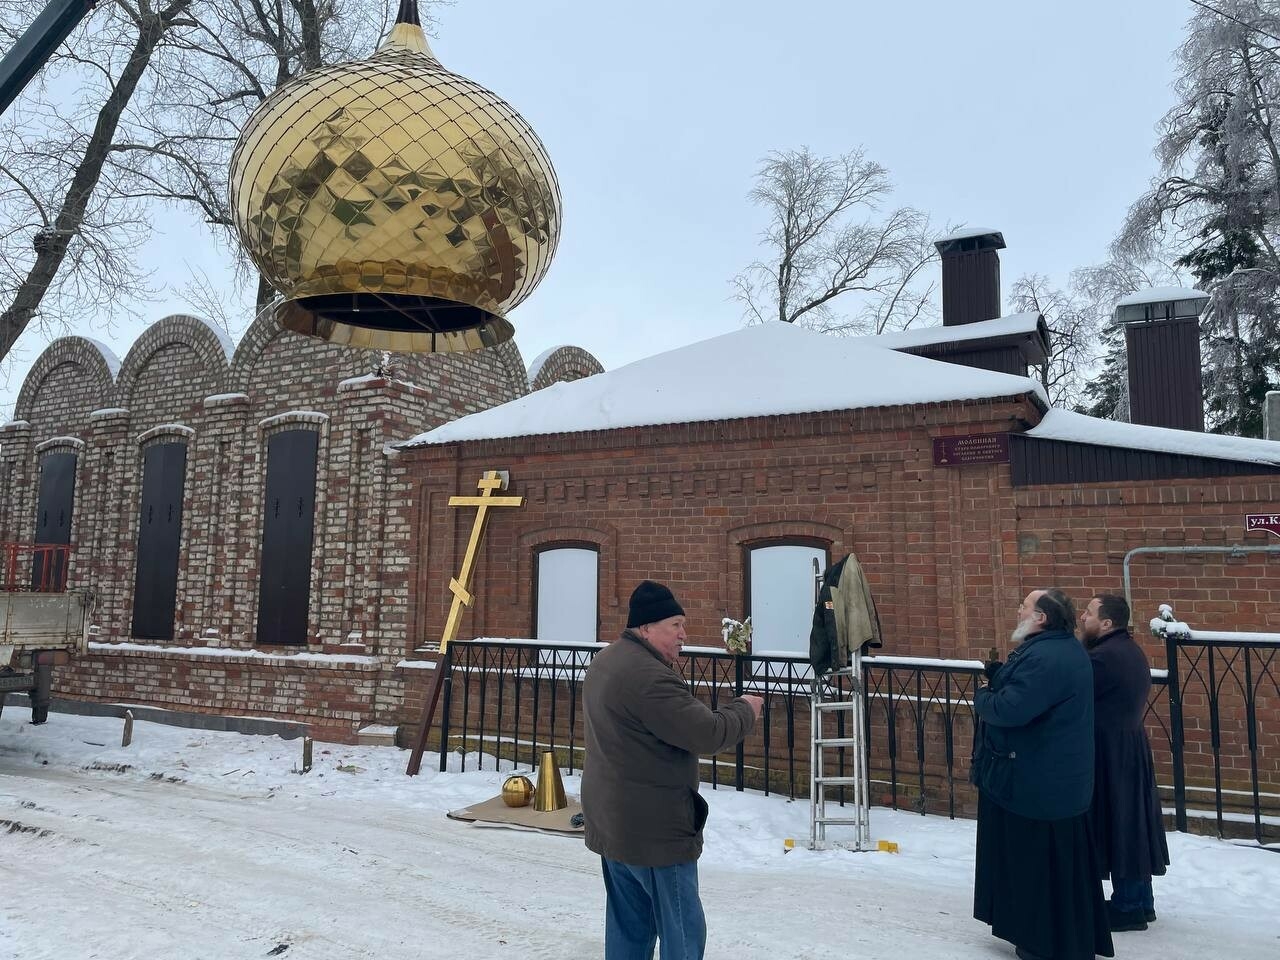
401;321;1047;447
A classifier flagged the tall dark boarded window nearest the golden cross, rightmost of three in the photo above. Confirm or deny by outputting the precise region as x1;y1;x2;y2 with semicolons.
257;430;320;644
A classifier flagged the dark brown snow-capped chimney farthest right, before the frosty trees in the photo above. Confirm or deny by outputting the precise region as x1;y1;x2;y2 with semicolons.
1115;287;1208;431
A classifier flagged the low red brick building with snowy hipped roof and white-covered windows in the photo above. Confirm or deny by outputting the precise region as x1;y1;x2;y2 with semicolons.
397;317;1280;817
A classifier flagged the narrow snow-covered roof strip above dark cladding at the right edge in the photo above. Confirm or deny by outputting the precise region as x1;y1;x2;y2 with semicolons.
1027;410;1280;466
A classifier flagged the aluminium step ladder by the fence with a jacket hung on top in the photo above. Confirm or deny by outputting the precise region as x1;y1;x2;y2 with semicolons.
809;655;872;851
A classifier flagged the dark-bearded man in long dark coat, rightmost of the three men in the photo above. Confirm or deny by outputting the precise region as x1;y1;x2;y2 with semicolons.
1080;594;1169;931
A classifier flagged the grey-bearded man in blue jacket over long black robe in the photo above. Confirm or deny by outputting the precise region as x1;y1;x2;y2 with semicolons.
970;590;1115;960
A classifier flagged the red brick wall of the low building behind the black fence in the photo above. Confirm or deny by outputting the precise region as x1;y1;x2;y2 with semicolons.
388;399;1280;806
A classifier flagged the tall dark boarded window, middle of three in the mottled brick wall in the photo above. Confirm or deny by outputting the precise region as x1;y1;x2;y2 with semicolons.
133;443;187;640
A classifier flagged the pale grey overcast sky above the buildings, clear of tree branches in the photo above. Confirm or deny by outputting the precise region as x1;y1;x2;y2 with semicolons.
0;0;1193;416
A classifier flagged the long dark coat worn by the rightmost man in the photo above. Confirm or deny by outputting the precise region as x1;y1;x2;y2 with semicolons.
1089;630;1169;881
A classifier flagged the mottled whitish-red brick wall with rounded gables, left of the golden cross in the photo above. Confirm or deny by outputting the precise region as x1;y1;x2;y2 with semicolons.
0;316;598;739
